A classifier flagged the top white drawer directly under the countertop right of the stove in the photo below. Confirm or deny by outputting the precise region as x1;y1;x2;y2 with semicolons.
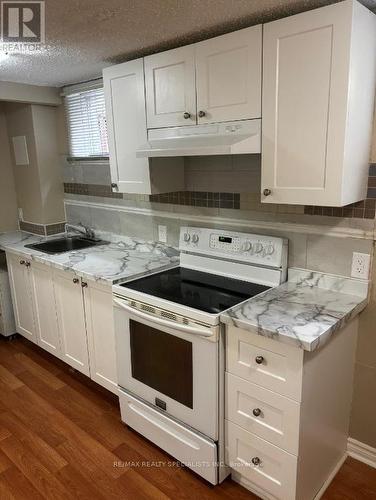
226;326;304;401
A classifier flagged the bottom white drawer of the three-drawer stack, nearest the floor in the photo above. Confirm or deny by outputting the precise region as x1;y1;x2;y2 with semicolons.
226;420;297;500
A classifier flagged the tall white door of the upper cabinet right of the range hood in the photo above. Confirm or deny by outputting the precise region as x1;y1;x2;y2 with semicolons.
261;2;352;205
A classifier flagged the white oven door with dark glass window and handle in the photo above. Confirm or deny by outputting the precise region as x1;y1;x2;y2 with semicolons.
114;297;219;441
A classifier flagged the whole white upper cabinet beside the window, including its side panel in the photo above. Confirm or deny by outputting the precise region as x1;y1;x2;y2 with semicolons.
103;59;184;194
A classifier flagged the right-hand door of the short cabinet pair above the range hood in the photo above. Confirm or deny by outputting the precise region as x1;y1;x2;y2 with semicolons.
196;25;262;123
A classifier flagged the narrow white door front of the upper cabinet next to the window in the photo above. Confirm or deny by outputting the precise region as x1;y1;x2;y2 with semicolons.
103;59;151;194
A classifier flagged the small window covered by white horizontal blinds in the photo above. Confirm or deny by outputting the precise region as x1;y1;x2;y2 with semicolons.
64;84;108;159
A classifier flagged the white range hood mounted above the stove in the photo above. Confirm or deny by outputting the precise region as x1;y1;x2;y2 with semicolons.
136;120;261;158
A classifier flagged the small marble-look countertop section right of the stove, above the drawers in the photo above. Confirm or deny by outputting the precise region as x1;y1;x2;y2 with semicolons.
221;269;368;351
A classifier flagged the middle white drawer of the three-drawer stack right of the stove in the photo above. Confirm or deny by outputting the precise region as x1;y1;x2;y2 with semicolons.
226;373;300;455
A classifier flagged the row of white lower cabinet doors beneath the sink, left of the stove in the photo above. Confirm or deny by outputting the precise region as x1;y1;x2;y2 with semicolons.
7;253;117;393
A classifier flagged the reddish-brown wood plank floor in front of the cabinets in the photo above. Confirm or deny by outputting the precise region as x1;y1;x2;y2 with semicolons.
0;338;376;500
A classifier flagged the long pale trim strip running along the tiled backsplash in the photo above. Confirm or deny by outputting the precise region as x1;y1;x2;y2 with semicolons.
64;199;374;240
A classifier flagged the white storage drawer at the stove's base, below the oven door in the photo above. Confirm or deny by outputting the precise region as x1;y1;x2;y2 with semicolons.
119;389;218;484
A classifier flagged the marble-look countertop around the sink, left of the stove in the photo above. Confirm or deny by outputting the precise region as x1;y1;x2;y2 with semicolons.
0;231;179;285
